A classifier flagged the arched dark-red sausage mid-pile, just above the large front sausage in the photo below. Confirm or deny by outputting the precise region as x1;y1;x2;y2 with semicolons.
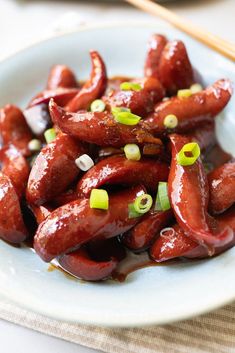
77;156;169;197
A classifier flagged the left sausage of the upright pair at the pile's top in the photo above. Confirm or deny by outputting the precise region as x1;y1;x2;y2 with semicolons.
144;34;167;78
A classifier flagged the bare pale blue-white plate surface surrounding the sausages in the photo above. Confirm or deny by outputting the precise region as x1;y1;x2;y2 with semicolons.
0;24;235;326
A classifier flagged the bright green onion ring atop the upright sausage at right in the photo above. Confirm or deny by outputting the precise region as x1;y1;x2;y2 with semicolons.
176;142;201;166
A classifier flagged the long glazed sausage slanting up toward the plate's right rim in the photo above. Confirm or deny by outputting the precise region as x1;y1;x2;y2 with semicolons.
143;80;233;134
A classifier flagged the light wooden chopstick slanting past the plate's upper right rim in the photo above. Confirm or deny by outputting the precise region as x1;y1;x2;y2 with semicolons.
126;0;235;61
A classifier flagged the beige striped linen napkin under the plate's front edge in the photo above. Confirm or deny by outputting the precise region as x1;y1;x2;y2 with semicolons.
0;298;235;353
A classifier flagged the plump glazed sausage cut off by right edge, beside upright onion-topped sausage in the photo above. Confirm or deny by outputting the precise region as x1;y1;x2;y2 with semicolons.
208;161;235;214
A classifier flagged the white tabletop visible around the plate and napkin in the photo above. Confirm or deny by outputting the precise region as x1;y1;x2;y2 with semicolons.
0;0;235;353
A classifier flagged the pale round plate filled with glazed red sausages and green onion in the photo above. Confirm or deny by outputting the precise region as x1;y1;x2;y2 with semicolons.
0;24;235;327
